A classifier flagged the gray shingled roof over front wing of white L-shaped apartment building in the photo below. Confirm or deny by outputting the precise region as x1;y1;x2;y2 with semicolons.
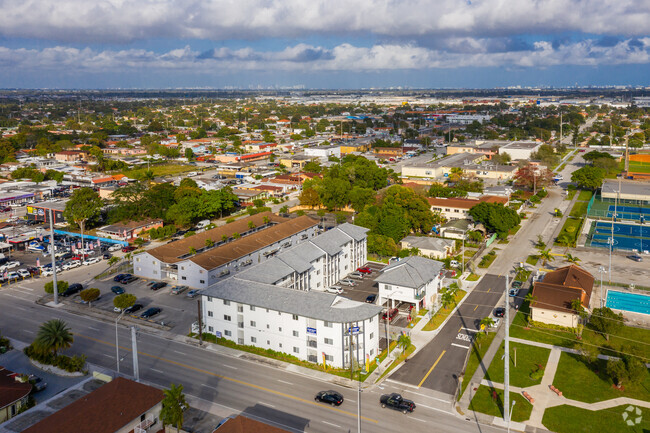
201;276;382;323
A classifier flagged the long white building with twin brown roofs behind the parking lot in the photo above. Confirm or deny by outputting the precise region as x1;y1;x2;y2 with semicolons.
133;212;318;289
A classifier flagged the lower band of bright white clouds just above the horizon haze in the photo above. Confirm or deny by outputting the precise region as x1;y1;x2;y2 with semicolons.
0;38;650;73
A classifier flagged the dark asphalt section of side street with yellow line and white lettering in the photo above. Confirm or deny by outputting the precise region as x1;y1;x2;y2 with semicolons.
390;275;505;395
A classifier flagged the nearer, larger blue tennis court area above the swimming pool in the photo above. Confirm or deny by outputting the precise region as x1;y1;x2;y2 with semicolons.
587;221;650;251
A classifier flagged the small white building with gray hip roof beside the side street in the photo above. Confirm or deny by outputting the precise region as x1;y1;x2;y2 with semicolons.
375;256;444;310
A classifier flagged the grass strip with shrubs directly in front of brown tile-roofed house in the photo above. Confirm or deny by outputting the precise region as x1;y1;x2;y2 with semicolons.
510;302;650;360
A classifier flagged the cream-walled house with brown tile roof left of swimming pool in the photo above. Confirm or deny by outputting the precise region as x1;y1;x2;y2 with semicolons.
530;265;594;328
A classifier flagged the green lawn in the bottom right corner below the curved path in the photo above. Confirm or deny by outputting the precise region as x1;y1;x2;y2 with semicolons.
540;405;650;433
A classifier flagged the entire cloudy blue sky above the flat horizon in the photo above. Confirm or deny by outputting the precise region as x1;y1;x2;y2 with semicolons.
0;0;650;89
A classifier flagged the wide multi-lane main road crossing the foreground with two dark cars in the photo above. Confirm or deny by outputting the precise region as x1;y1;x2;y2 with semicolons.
0;289;502;432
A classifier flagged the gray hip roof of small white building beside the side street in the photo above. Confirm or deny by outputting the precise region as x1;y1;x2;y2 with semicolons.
375;256;444;289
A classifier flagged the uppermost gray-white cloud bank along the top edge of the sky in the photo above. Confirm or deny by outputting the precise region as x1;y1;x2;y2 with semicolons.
0;0;650;44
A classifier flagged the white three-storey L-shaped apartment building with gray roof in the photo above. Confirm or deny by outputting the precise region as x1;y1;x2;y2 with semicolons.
201;224;382;368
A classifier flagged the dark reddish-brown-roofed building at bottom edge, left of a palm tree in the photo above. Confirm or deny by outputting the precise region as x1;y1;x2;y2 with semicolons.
23;377;164;433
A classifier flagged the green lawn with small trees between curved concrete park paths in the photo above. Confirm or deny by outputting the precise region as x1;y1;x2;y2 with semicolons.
553;352;650;403
